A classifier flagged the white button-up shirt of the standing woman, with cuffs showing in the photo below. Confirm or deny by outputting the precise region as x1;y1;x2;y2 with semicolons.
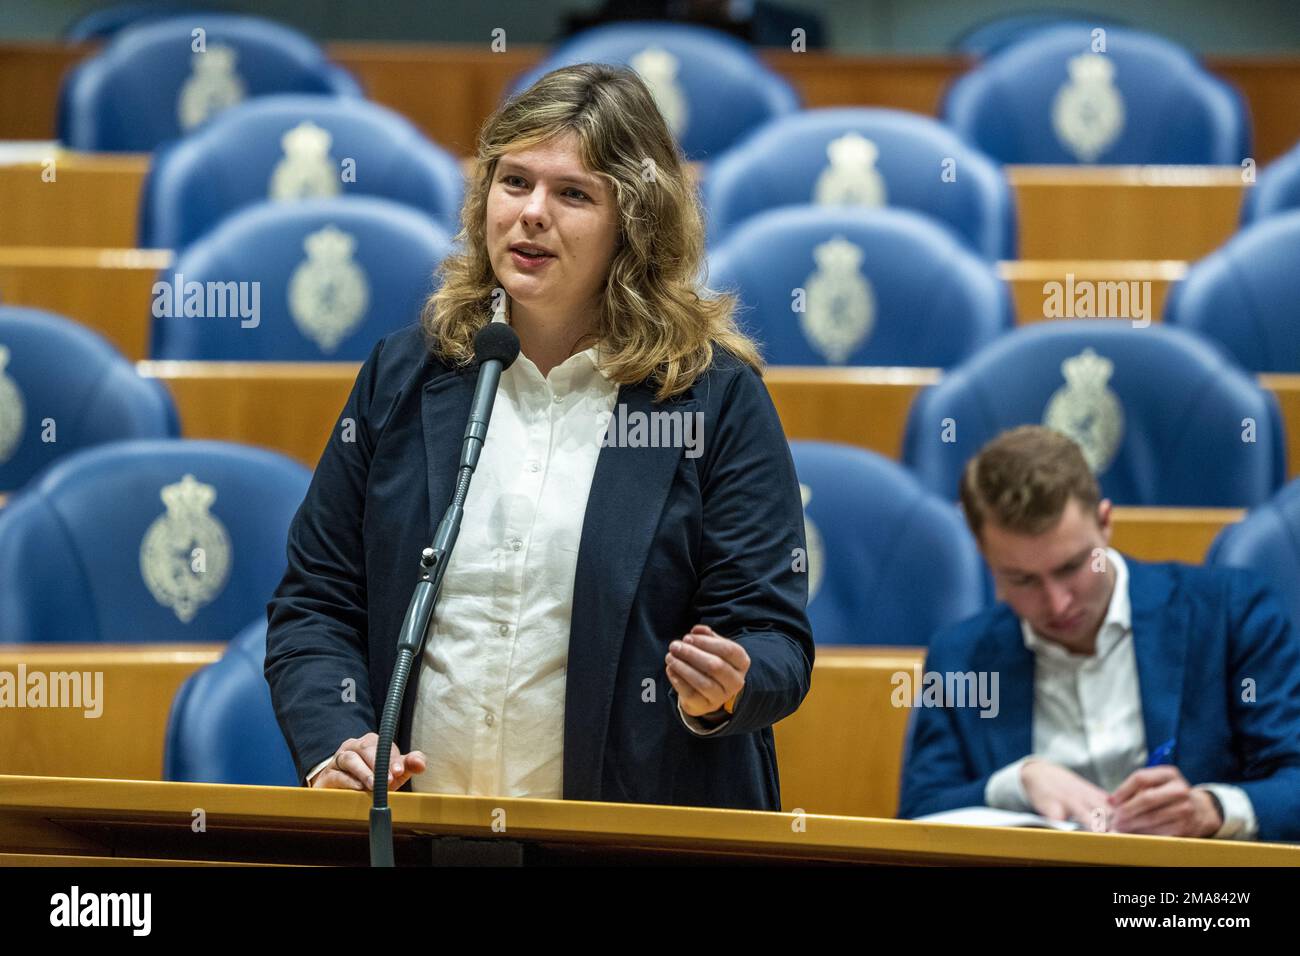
307;314;725;799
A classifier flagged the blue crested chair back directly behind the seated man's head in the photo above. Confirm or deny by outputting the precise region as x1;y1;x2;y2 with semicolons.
904;319;1286;507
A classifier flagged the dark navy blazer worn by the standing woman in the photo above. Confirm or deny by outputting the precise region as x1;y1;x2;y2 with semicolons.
265;326;814;810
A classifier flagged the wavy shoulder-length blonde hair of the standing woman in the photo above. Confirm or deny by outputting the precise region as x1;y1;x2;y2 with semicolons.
421;64;763;402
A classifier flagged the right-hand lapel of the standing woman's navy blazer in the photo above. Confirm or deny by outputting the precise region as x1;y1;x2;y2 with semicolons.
564;384;698;800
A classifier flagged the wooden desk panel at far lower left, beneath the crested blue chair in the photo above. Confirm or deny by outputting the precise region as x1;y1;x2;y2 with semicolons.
0;644;222;780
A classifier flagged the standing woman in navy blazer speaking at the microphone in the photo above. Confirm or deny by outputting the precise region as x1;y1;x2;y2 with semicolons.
265;64;814;810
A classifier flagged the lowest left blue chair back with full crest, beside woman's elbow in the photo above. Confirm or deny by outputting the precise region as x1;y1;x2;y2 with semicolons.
0;438;311;644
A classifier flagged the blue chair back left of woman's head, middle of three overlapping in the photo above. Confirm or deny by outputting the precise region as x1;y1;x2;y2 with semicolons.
139;94;464;248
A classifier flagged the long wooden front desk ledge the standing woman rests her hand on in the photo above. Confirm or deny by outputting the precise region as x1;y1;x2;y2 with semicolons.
0;777;1300;866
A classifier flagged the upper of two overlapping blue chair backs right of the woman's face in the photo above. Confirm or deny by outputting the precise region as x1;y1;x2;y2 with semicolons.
703;107;1015;259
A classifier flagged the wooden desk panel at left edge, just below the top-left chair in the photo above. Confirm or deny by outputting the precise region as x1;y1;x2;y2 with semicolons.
0;151;150;248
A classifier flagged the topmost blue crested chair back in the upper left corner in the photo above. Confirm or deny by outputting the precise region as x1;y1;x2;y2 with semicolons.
59;13;361;152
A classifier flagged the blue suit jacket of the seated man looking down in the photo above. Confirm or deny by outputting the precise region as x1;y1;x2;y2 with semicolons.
898;555;1300;840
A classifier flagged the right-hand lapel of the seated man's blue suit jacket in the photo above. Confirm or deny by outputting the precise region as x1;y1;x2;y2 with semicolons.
1125;557;1187;762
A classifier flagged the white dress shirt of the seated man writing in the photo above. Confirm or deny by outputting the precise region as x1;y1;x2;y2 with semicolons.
984;548;1257;840
